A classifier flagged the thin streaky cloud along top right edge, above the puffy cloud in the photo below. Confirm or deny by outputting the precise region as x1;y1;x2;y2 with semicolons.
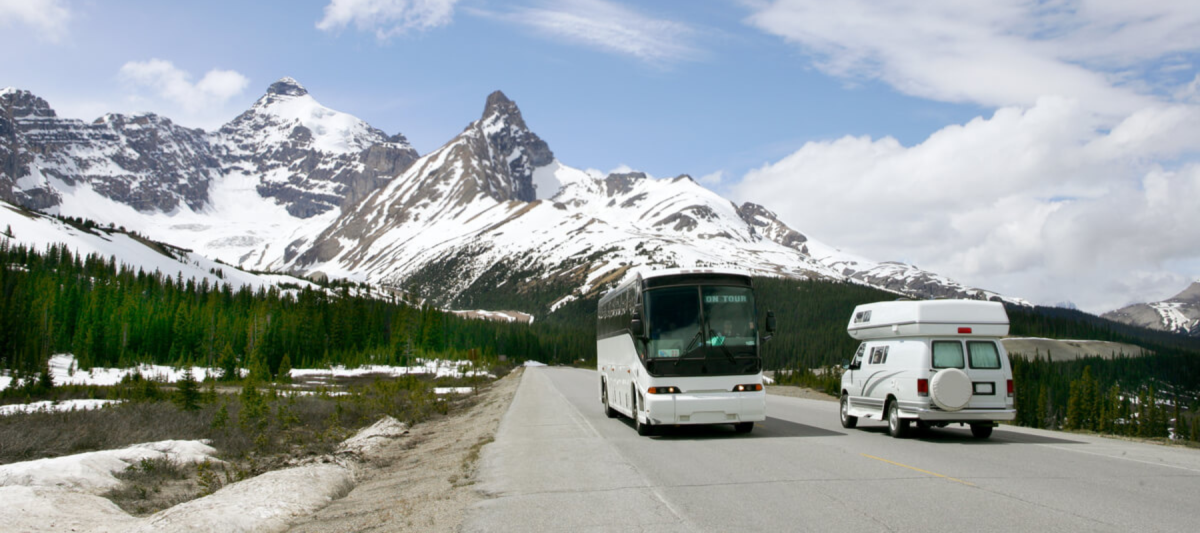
748;0;1200;116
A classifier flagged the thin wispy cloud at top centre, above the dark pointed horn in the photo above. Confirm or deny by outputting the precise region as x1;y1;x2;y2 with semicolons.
484;0;697;65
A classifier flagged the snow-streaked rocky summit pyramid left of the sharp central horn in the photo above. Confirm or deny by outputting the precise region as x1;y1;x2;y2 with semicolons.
216;78;416;218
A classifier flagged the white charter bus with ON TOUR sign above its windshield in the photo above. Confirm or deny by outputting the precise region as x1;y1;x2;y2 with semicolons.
596;270;775;435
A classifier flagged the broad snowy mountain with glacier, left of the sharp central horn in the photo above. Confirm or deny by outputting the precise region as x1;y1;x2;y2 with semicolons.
0;78;416;270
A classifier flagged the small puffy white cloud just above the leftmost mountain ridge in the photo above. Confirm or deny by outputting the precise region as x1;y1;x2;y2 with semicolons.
118;59;250;127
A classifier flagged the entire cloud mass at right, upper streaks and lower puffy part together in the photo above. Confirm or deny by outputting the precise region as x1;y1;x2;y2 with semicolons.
733;0;1200;312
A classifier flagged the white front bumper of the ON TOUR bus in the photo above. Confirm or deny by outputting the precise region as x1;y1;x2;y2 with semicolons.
644;390;767;425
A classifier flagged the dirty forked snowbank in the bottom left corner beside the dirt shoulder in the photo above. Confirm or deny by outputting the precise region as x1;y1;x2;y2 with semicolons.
0;417;408;533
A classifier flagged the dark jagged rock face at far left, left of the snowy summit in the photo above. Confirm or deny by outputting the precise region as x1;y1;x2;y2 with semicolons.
0;89;220;211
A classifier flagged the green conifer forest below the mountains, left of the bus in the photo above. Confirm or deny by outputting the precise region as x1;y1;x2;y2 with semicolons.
0;240;585;376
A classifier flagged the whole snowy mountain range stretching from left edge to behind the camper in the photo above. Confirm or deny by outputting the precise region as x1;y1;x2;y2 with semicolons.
0;78;1041;315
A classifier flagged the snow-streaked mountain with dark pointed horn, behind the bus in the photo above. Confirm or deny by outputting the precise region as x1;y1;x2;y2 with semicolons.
289;88;1015;309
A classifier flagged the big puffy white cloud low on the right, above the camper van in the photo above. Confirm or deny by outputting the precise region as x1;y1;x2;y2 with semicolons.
733;97;1200;312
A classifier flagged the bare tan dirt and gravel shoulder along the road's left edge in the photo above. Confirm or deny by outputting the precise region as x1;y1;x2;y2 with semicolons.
292;369;523;532
